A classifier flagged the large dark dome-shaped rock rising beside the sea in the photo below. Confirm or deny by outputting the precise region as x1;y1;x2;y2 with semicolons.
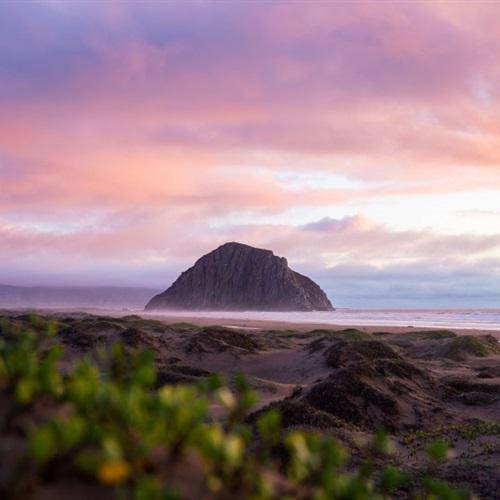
146;243;333;311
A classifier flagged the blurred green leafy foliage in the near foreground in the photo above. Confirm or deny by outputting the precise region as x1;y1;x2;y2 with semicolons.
0;320;470;500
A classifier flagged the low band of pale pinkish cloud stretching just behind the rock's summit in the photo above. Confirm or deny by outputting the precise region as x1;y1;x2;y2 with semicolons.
0;210;500;267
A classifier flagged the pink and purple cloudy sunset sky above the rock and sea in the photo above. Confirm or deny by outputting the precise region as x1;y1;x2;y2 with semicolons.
0;0;500;308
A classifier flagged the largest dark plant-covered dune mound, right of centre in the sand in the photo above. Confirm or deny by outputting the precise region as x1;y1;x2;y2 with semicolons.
300;336;443;431
